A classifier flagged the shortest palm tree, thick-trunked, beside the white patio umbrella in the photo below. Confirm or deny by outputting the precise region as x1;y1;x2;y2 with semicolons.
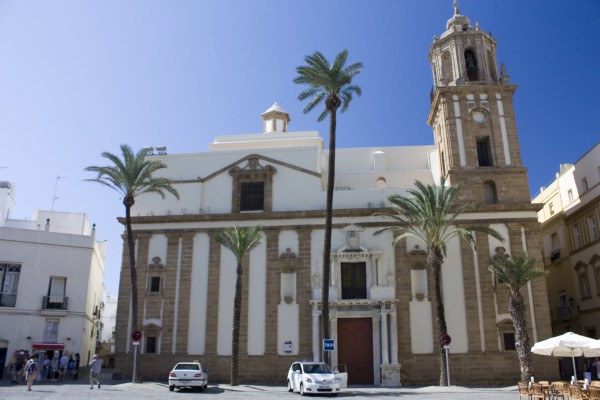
489;253;548;382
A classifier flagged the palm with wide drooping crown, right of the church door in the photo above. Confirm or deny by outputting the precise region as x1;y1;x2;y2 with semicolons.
375;178;504;386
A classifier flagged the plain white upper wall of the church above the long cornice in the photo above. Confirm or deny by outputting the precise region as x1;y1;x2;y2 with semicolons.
132;142;436;216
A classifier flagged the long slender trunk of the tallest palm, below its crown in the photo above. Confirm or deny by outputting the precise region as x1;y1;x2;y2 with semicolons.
321;108;337;364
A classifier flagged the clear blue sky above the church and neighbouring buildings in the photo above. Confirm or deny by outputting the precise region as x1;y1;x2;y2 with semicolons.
0;0;600;293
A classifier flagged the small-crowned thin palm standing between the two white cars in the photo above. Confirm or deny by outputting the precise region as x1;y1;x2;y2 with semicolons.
217;226;262;386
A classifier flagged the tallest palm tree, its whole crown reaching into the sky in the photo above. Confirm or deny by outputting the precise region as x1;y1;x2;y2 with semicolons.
294;50;363;362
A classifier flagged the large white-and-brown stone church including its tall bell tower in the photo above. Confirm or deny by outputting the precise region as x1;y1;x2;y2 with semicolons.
115;7;551;385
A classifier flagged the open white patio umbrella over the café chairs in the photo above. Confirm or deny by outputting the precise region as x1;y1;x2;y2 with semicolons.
531;332;600;380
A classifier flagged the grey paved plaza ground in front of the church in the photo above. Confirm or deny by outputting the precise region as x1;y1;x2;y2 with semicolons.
0;379;517;400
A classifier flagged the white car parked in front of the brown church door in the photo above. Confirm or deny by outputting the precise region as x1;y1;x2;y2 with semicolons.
287;361;347;396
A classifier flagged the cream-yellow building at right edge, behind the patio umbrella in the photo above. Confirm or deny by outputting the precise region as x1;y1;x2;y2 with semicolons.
533;142;600;338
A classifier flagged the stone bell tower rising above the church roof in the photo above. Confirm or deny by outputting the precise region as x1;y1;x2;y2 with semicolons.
427;0;531;207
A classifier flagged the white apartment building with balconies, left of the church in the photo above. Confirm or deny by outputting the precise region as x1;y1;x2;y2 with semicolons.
0;181;106;378
